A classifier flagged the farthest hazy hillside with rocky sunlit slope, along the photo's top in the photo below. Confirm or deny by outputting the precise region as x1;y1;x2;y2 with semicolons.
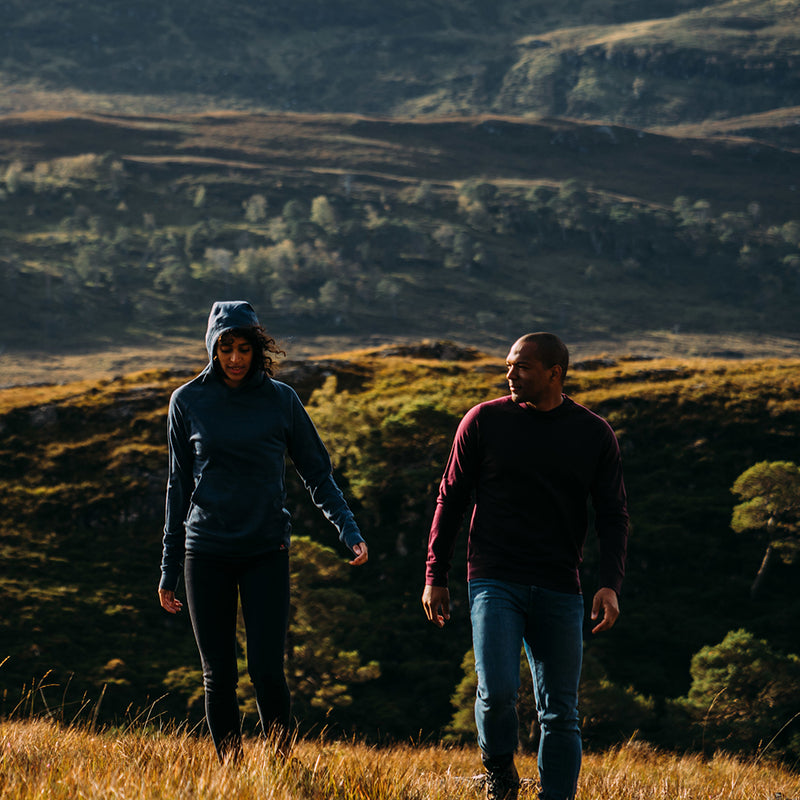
0;0;800;130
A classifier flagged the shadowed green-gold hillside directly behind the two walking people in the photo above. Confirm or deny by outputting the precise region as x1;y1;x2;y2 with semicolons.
0;343;800;753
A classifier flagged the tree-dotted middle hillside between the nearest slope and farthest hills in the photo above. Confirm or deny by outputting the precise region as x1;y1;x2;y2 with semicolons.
0;112;800;385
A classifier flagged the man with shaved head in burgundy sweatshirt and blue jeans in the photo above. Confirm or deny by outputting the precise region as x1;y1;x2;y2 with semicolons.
422;333;628;800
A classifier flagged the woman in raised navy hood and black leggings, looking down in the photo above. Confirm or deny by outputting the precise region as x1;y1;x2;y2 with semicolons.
158;301;368;759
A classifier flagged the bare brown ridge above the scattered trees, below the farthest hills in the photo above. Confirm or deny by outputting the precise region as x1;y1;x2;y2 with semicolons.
0;111;800;219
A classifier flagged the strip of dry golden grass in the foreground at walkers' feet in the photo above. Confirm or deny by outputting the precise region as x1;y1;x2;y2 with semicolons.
0;720;800;800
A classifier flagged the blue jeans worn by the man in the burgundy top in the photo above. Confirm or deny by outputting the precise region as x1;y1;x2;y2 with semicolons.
469;579;583;800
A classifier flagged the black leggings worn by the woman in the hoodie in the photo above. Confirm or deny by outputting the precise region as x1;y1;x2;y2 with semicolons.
184;551;290;758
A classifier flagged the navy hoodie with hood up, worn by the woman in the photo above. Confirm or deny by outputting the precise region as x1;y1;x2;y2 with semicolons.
159;300;364;591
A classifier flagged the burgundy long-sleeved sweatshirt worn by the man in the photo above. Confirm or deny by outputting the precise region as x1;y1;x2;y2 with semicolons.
426;395;628;594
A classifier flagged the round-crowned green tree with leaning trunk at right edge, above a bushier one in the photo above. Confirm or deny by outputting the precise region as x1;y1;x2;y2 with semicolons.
731;461;800;597
